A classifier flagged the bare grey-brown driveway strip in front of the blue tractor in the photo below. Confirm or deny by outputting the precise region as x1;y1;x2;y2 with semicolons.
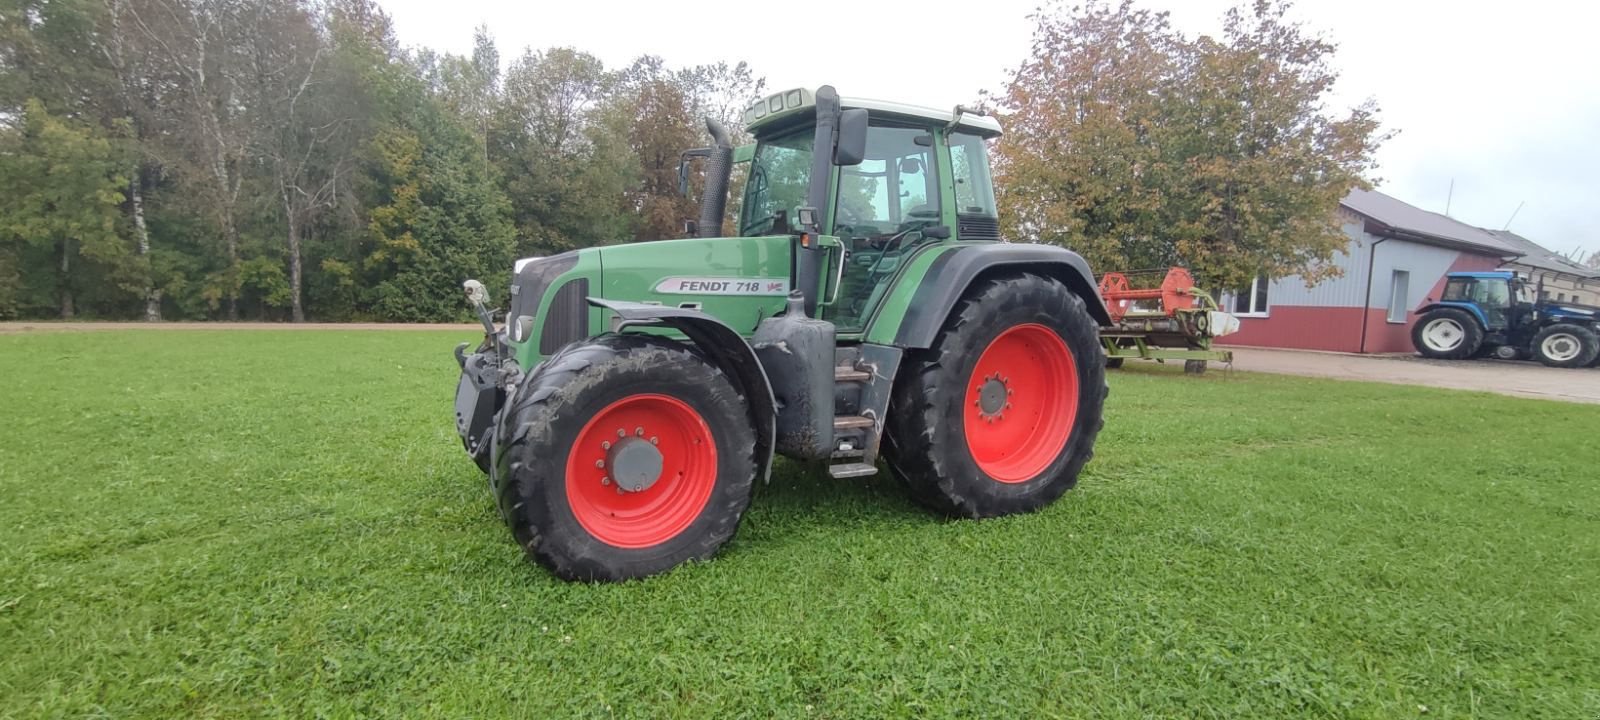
1230;347;1600;403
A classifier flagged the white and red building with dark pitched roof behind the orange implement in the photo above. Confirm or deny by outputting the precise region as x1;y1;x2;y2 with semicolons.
1222;190;1523;352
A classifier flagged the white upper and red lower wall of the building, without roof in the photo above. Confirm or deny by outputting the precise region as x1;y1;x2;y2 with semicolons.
1222;208;1501;352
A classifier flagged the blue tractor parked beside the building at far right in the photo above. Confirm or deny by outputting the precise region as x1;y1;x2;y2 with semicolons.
1411;270;1600;368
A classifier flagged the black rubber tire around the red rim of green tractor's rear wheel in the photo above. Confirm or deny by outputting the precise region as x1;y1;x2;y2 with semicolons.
885;274;1107;518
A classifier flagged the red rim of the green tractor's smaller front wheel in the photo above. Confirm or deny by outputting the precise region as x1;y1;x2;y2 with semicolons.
566;394;717;547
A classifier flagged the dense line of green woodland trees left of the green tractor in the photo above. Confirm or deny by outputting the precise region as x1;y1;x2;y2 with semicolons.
0;0;765;322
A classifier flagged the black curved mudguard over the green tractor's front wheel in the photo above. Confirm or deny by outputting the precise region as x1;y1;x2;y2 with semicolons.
586;298;778;482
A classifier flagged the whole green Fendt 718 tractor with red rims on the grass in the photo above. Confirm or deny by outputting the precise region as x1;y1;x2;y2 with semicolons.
444;86;1109;579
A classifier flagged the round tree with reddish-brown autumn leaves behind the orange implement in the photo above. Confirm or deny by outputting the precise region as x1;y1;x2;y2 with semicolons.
995;0;1386;286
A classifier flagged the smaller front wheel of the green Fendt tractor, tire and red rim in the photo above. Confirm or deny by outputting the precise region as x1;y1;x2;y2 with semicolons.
494;334;755;581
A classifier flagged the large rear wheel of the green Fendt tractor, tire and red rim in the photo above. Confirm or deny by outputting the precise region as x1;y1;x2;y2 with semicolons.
886;274;1106;517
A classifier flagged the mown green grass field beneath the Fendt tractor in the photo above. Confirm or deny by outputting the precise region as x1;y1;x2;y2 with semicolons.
0;331;1600;720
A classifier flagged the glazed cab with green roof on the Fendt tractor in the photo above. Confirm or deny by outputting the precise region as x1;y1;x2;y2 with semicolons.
732;90;1000;333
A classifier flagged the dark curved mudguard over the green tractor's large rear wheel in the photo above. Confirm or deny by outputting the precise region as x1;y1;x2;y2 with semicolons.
869;243;1110;349
